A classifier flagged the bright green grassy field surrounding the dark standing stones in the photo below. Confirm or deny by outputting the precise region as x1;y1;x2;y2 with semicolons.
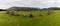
0;10;60;26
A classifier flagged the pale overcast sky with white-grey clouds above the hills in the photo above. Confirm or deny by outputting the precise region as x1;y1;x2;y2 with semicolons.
0;0;60;9
